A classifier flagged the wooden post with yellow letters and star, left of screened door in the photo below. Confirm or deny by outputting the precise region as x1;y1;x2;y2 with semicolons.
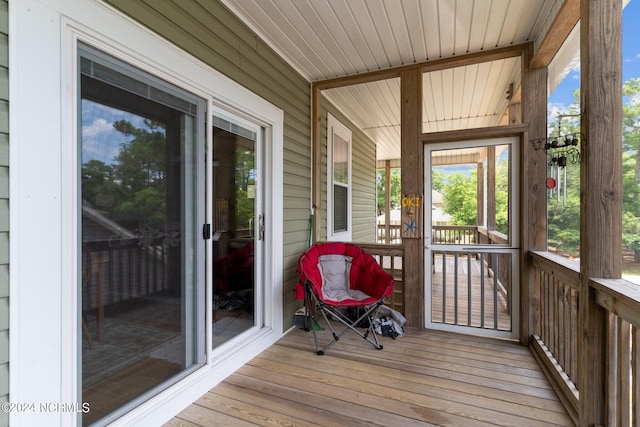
400;68;422;328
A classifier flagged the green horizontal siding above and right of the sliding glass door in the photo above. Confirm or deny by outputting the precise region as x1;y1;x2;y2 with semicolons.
106;0;311;329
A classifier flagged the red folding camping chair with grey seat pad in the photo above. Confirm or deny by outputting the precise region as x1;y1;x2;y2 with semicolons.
296;242;394;355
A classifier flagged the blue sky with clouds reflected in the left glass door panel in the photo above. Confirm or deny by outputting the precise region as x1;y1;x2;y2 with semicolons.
82;99;154;165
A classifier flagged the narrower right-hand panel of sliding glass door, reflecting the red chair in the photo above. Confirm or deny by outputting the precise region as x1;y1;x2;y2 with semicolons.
212;115;265;348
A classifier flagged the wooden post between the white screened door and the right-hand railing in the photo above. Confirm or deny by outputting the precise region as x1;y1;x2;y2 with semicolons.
520;46;548;345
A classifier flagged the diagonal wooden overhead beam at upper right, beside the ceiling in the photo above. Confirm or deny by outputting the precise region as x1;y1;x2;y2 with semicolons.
530;0;580;68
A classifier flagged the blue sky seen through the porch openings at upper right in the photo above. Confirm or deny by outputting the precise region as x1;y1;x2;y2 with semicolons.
549;0;640;105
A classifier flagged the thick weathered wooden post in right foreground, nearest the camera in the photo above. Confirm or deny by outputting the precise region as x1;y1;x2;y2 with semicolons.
578;0;622;426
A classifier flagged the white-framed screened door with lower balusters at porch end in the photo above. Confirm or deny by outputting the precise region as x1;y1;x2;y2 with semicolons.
424;137;520;339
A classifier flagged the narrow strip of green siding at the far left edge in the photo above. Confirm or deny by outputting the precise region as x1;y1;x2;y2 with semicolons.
0;1;9;427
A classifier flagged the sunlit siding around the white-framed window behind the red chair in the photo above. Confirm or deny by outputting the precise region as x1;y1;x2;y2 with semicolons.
318;98;376;243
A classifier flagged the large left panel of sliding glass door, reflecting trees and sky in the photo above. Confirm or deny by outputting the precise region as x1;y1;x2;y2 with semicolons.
78;46;205;425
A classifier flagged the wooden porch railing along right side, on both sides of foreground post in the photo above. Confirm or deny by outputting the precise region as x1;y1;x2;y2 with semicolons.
531;252;640;426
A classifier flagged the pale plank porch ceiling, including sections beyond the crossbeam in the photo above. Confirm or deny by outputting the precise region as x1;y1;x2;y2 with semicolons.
222;0;562;160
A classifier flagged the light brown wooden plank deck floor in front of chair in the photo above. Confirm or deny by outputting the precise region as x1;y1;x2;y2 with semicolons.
167;329;573;427
